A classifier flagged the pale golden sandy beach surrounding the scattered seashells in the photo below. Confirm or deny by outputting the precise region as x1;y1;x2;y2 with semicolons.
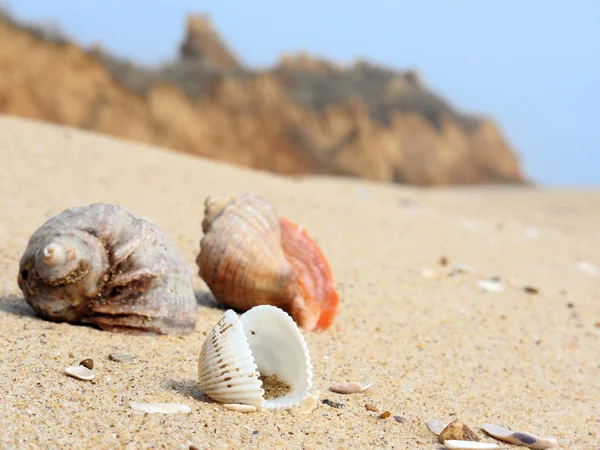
0;116;600;450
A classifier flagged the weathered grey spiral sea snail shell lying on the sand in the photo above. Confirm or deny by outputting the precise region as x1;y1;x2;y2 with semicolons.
18;203;198;334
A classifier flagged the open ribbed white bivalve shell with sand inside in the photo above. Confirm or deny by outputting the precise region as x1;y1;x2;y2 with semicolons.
198;305;312;410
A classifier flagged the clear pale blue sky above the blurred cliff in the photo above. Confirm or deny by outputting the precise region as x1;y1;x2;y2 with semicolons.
0;0;600;185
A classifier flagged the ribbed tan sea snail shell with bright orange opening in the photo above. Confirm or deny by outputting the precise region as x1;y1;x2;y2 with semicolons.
196;193;339;331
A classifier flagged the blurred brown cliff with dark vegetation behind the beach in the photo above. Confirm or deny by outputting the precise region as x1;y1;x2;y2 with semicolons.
0;13;526;185
